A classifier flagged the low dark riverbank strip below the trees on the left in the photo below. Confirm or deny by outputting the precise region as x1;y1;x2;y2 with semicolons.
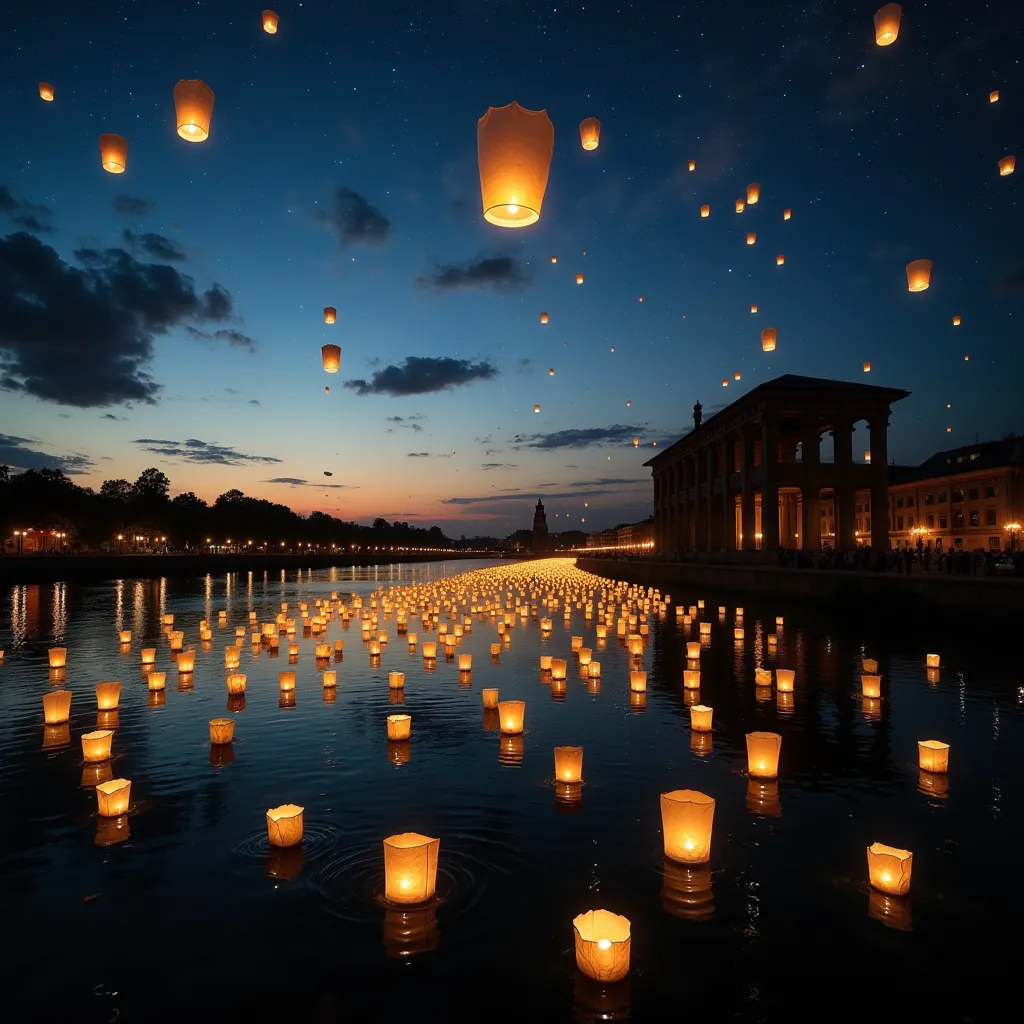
0;551;504;586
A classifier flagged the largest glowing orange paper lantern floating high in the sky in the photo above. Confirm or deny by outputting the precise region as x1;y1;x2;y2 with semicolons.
476;101;555;227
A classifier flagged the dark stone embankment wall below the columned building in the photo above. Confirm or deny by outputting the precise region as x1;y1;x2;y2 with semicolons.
577;558;1024;621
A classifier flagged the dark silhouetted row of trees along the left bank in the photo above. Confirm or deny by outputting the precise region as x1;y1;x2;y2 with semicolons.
0;466;471;551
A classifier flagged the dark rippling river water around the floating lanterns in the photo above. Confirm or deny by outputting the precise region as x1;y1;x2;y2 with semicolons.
0;562;1024;1022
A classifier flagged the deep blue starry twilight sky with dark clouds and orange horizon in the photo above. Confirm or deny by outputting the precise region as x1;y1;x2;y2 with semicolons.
0;0;1024;536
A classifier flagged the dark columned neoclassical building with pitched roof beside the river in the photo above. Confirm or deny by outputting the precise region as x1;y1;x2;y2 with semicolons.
644;374;910;553
